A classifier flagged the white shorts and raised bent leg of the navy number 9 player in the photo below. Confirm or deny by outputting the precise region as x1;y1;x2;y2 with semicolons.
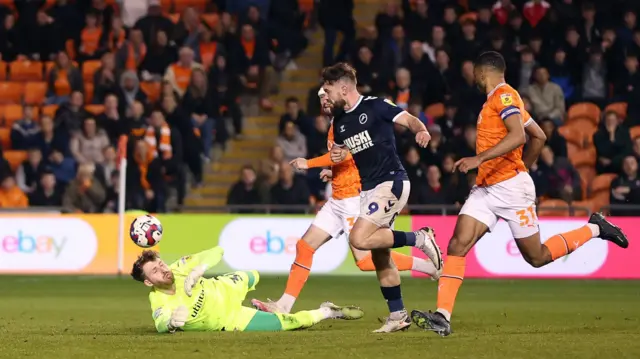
349;181;442;269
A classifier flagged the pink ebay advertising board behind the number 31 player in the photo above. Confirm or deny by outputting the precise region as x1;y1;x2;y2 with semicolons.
412;216;640;279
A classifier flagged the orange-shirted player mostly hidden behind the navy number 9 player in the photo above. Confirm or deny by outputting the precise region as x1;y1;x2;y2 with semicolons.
251;88;440;313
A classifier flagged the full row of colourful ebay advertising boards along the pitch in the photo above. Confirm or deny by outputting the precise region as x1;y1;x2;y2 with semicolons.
0;213;640;279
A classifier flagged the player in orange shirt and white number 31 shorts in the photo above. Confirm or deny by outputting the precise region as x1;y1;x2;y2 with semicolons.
411;51;629;336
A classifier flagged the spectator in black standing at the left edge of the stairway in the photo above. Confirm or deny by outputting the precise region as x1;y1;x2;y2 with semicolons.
209;56;243;142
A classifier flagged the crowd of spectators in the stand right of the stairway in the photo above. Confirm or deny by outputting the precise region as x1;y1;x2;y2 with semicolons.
228;0;640;215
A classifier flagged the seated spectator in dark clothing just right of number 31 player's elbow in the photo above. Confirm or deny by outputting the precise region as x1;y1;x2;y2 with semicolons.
539;146;582;203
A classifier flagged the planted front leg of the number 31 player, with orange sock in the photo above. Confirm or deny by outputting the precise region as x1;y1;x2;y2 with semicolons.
411;187;498;336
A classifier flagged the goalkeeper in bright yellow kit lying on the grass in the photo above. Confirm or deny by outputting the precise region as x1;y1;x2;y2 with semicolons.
131;247;364;333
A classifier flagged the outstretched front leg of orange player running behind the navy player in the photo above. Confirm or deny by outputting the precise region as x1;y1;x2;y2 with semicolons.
251;198;342;313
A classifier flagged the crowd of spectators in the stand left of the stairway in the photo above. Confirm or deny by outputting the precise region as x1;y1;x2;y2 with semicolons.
0;0;307;213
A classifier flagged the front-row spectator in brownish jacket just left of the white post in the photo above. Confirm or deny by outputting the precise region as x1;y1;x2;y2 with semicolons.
62;163;106;213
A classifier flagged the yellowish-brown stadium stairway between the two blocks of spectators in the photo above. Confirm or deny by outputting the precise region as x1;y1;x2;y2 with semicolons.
183;0;384;212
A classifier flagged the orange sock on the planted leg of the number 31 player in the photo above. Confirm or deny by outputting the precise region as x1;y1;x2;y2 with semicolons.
438;256;466;320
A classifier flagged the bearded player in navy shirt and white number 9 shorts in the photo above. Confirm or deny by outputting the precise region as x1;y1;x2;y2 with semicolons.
322;63;442;333
